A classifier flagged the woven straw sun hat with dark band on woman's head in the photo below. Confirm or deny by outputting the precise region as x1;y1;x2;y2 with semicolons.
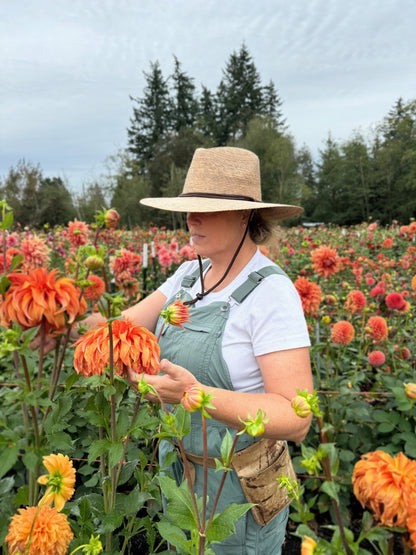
140;146;303;220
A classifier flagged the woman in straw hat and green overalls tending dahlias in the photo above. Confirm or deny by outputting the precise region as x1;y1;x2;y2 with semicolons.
124;147;313;555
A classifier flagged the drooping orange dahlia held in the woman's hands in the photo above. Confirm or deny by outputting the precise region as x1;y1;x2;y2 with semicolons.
74;319;160;378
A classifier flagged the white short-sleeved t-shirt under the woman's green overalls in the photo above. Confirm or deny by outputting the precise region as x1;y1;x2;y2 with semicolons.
159;249;310;393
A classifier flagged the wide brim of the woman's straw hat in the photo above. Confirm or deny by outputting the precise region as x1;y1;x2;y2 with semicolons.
140;197;303;220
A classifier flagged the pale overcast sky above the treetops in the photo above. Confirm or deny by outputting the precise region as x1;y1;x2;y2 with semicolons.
0;0;416;191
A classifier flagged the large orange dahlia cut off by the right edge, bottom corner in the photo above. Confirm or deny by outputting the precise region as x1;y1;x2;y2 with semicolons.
352;451;416;527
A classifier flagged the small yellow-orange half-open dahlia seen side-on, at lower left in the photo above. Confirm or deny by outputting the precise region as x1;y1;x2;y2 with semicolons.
38;453;75;511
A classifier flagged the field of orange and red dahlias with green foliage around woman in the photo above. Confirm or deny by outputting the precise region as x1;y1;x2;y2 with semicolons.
0;205;416;555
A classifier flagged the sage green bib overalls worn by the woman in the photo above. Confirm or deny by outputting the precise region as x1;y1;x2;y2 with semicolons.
155;261;289;555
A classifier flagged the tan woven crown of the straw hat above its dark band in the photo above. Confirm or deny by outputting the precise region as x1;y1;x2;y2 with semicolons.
182;147;261;202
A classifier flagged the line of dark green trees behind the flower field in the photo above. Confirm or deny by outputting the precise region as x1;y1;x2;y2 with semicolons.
0;44;416;229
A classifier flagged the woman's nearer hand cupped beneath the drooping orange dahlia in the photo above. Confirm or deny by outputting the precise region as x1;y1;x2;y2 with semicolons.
127;359;198;405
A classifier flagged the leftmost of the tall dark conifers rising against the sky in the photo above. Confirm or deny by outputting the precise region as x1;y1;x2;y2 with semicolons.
127;62;173;165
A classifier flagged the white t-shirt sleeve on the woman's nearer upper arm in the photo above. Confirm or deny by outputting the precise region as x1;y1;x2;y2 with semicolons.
249;275;310;356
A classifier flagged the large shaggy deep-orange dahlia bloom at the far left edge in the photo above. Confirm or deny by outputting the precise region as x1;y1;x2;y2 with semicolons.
0;268;87;333
